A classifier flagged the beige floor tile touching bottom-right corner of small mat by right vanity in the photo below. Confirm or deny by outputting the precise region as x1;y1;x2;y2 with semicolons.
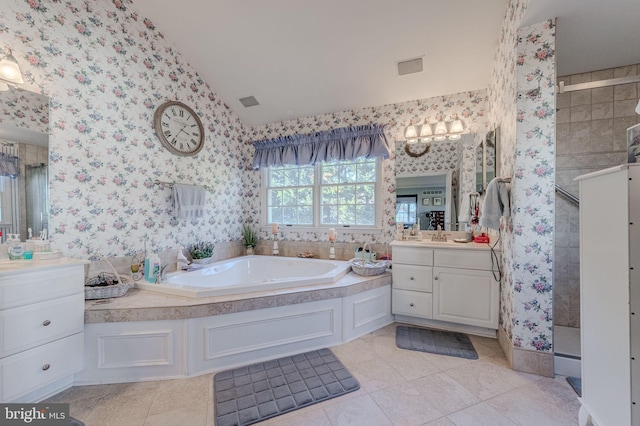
445;361;515;400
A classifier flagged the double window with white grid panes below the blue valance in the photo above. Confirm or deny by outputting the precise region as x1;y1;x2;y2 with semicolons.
265;158;380;228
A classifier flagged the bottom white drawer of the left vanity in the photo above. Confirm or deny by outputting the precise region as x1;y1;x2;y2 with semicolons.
0;333;84;402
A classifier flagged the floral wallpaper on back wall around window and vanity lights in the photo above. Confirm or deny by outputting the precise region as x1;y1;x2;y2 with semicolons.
248;90;488;243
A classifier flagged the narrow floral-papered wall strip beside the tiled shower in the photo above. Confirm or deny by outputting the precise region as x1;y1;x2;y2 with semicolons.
509;20;556;351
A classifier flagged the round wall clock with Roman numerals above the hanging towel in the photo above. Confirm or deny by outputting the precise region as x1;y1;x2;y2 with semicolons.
153;101;204;156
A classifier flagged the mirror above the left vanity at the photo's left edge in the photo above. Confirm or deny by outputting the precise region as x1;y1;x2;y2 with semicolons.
0;88;49;242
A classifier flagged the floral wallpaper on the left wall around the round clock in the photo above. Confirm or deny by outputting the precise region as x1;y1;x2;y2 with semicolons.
0;0;250;258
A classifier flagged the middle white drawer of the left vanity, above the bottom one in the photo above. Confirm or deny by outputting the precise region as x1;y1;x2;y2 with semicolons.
0;294;84;357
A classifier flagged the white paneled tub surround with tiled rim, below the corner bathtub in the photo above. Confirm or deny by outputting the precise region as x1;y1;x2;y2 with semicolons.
76;273;393;384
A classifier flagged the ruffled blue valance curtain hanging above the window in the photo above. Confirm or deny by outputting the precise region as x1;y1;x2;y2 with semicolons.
253;124;389;170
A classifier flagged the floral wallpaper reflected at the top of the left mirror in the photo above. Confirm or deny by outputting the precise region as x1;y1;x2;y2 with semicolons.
0;89;49;133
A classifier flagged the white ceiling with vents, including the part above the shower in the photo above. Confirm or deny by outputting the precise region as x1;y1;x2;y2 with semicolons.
134;0;640;125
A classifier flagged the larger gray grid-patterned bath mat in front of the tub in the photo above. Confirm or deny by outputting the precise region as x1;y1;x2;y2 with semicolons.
213;349;360;426
